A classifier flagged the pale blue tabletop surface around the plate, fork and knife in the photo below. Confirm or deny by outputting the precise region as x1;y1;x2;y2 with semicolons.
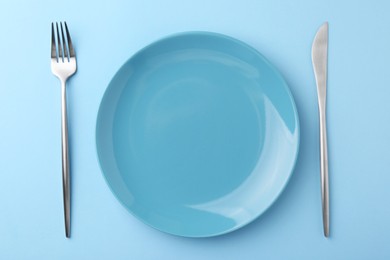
0;0;390;259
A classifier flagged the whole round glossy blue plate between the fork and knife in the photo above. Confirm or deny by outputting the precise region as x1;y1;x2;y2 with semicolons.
96;32;299;237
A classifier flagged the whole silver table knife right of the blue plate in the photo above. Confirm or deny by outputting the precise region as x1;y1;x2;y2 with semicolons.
311;22;329;237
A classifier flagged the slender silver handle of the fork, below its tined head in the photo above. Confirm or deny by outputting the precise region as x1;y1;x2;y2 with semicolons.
61;80;70;238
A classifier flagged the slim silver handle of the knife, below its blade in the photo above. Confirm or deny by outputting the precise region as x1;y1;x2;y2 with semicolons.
319;102;329;237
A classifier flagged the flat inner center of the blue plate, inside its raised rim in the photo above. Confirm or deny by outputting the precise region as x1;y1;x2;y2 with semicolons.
114;63;264;206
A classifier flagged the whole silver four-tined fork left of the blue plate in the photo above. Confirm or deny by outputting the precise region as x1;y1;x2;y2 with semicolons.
51;22;76;238
